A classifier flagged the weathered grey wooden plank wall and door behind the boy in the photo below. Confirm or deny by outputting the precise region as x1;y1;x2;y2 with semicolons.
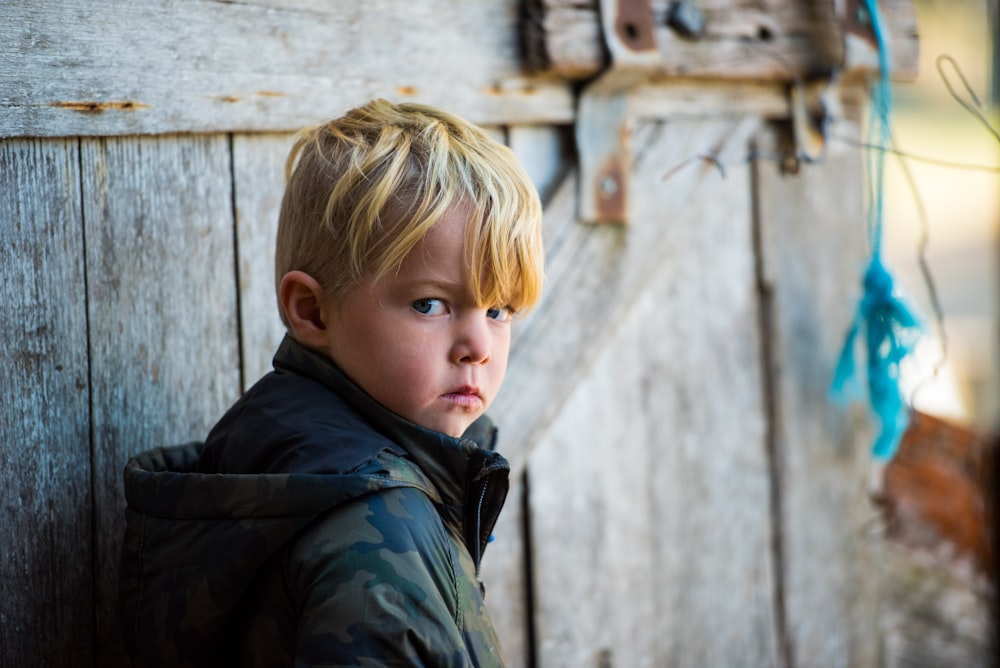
0;0;920;667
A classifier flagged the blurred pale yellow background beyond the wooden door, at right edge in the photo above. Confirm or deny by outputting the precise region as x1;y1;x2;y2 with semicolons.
884;0;1000;430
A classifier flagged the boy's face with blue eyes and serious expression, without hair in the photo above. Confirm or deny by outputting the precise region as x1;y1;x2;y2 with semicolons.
323;208;511;437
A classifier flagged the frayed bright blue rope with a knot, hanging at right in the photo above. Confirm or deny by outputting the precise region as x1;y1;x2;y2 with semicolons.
832;0;922;460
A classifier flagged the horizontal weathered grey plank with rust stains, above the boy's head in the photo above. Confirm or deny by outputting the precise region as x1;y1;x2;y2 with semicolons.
0;0;573;136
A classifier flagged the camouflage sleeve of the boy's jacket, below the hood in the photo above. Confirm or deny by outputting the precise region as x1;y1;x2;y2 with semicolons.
288;488;473;668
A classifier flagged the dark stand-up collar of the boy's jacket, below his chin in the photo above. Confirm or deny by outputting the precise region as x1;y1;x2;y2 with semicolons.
274;335;509;507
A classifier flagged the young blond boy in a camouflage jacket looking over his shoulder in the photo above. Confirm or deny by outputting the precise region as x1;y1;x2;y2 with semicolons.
121;100;542;666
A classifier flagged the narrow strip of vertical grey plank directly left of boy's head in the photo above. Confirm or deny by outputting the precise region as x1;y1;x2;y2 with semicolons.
233;134;292;390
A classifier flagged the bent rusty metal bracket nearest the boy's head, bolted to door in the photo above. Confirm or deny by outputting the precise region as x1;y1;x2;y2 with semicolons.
576;0;660;224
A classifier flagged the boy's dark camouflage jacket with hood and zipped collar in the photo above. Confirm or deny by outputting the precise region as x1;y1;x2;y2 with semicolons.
120;338;509;667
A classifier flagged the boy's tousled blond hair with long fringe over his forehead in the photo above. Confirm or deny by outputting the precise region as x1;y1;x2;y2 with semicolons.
275;100;543;325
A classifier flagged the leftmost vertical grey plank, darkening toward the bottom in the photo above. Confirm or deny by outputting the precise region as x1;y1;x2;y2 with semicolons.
0;140;94;666
